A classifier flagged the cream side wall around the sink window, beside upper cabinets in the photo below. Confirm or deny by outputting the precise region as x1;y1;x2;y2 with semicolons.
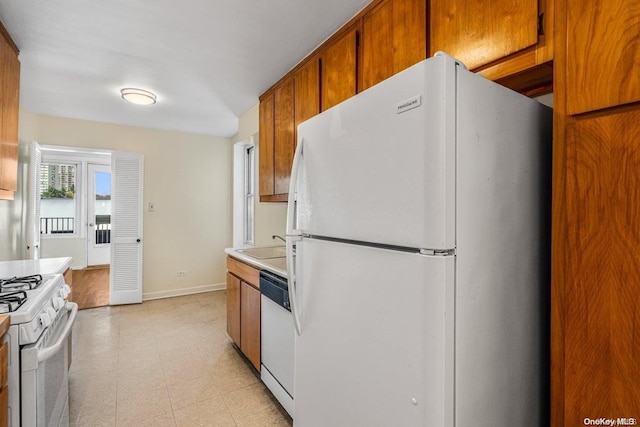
232;104;287;246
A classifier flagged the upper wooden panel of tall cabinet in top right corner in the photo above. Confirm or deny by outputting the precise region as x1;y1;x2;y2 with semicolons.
566;0;640;114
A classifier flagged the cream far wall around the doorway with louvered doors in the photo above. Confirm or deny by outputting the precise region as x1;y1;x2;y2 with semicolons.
15;108;232;299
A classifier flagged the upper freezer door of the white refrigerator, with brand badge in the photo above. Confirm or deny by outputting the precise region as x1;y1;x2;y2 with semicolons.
293;56;457;249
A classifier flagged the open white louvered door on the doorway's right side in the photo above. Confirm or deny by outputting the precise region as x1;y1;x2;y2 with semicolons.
109;151;144;305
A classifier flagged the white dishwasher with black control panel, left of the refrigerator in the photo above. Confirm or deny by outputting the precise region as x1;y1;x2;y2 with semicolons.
260;271;295;417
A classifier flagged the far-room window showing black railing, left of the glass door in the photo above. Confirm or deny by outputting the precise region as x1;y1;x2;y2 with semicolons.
40;162;80;235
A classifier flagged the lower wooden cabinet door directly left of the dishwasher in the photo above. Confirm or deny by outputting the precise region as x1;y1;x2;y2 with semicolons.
240;282;260;370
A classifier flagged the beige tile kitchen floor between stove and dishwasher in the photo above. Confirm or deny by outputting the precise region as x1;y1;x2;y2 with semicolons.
69;291;292;427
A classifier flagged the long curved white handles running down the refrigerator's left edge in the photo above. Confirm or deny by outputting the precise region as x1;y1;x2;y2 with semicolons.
286;139;304;335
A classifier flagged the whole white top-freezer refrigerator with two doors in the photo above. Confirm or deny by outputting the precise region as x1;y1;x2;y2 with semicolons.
287;54;552;427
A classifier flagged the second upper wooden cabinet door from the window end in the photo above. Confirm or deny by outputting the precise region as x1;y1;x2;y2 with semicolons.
273;78;295;194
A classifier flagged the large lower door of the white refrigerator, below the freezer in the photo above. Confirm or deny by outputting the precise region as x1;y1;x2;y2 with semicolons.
294;239;455;427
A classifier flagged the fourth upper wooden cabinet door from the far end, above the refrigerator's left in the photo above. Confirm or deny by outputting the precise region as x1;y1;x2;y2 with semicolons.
320;25;358;111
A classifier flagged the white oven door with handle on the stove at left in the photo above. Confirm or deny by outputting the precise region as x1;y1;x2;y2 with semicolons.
21;302;78;427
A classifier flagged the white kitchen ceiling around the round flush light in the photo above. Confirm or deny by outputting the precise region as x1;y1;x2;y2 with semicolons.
0;0;370;137
